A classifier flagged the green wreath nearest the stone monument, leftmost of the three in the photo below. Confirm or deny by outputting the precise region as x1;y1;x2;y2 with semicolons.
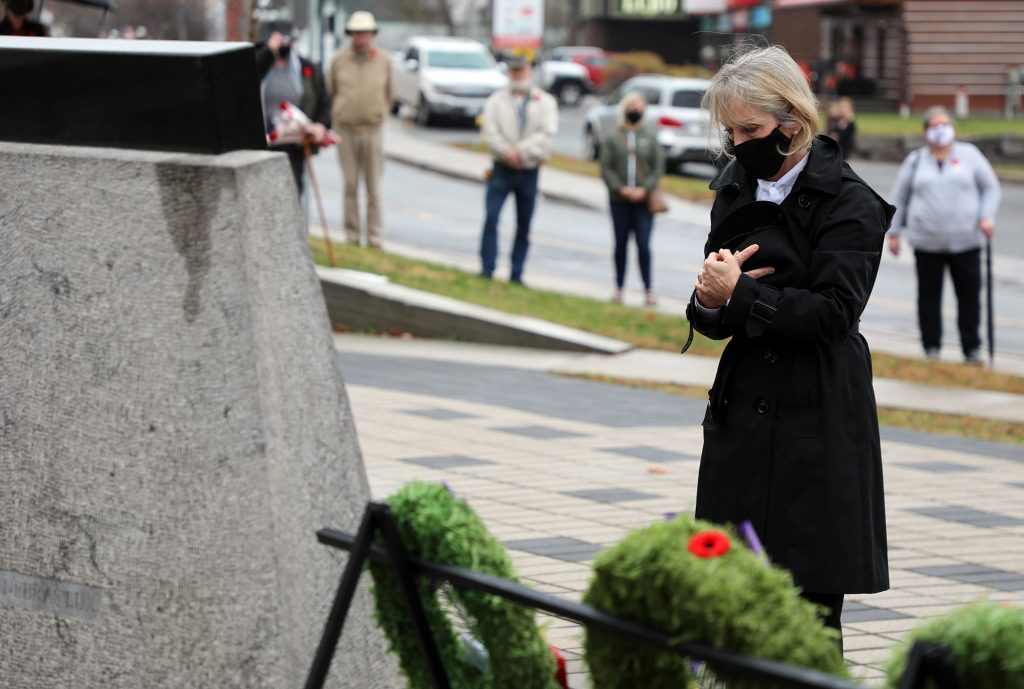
370;481;558;689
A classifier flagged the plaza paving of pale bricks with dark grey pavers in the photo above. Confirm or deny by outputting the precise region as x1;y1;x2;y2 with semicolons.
339;345;1024;689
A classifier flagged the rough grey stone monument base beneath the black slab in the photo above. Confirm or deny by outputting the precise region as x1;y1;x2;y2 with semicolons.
0;42;399;689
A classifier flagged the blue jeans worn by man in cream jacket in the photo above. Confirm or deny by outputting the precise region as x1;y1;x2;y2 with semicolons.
480;163;538;281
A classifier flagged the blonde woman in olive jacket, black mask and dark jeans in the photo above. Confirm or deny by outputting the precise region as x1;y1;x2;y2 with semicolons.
601;91;665;306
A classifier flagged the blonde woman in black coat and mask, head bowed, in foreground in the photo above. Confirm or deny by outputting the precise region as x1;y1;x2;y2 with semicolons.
687;47;894;647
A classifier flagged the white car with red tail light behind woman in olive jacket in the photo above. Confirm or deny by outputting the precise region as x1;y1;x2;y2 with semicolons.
584;75;715;171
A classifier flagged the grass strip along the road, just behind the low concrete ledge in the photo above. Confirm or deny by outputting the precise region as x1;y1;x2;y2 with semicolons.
310;239;1024;394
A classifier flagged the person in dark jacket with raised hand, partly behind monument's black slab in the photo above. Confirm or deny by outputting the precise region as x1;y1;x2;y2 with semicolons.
256;31;331;197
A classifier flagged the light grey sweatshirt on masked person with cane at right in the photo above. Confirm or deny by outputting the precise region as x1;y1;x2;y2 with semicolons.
889;141;999;254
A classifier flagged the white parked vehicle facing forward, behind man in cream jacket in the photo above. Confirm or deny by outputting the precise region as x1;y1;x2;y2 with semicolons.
392;36;508;126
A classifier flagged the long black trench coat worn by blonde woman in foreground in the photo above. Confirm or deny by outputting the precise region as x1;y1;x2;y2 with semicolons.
687;136;895;594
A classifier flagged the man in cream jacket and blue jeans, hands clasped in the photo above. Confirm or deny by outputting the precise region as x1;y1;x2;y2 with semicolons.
480;55;558;285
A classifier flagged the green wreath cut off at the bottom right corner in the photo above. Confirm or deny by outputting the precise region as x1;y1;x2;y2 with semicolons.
886;601;1024;689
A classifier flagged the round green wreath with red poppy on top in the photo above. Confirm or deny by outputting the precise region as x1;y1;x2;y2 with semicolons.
584;516;849;689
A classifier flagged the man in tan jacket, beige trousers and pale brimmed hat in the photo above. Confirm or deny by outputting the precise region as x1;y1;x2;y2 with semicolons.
328;11;393;248
